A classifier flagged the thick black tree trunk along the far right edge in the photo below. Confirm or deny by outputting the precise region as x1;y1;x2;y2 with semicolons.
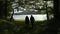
53;0;60;33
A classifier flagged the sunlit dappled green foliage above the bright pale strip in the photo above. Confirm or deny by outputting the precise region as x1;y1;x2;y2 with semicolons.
13;0;53;20
